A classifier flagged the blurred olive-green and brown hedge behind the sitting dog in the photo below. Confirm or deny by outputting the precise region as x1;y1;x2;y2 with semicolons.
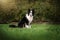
0;0;60;23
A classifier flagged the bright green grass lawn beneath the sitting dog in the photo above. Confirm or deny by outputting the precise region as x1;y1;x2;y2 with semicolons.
0;23;60;40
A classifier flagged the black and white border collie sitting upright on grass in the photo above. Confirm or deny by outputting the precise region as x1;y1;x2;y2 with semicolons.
18;9;34;28
